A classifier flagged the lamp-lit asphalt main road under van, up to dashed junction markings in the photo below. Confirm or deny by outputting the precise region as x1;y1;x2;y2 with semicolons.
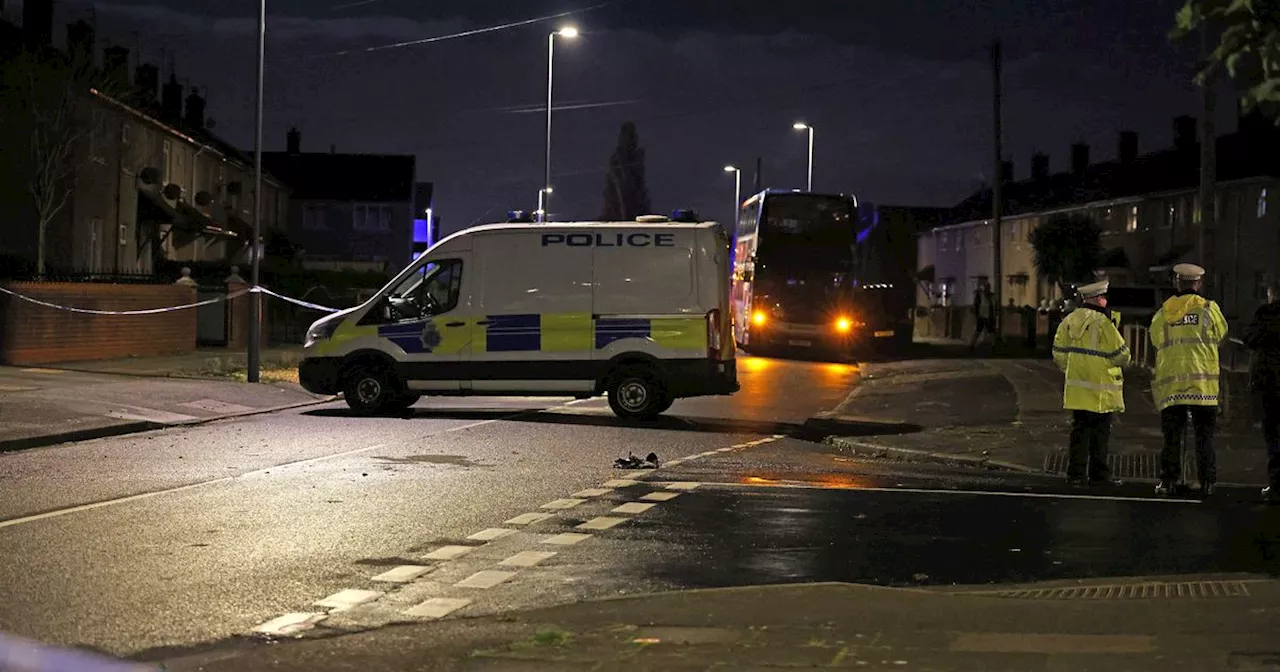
0;358;856;655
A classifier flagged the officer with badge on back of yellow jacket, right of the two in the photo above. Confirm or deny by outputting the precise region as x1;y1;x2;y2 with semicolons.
1151;264;1226;497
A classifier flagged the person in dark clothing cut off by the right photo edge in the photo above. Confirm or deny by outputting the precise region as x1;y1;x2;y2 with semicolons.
1244;283;1280;504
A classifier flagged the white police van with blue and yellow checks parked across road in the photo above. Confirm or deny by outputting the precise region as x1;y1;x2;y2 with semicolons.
298;215;739;419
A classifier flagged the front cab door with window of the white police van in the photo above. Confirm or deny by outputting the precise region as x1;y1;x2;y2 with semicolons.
378;252;474;392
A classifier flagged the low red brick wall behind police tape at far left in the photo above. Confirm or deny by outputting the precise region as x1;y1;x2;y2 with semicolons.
0;283;196;365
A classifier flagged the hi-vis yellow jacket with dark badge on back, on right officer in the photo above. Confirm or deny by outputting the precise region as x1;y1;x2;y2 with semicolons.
1151;292;1226;411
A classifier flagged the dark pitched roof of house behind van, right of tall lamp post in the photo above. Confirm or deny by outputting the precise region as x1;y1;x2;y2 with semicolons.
262;152;417;202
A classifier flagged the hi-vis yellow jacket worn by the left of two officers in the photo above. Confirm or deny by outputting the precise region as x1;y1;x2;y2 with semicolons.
1053;305;1129;413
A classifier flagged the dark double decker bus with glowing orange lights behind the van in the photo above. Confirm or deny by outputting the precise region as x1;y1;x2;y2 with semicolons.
732;189;911;355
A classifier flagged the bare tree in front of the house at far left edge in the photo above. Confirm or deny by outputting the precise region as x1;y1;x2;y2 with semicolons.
0;51;113;275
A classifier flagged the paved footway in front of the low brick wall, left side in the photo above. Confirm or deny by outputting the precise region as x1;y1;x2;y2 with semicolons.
0;345;329;452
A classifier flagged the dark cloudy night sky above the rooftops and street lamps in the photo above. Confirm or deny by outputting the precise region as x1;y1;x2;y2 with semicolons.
32;0;1208;230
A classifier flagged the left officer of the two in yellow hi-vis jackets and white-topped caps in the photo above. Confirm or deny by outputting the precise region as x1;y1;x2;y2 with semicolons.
1053;280;1129;486
